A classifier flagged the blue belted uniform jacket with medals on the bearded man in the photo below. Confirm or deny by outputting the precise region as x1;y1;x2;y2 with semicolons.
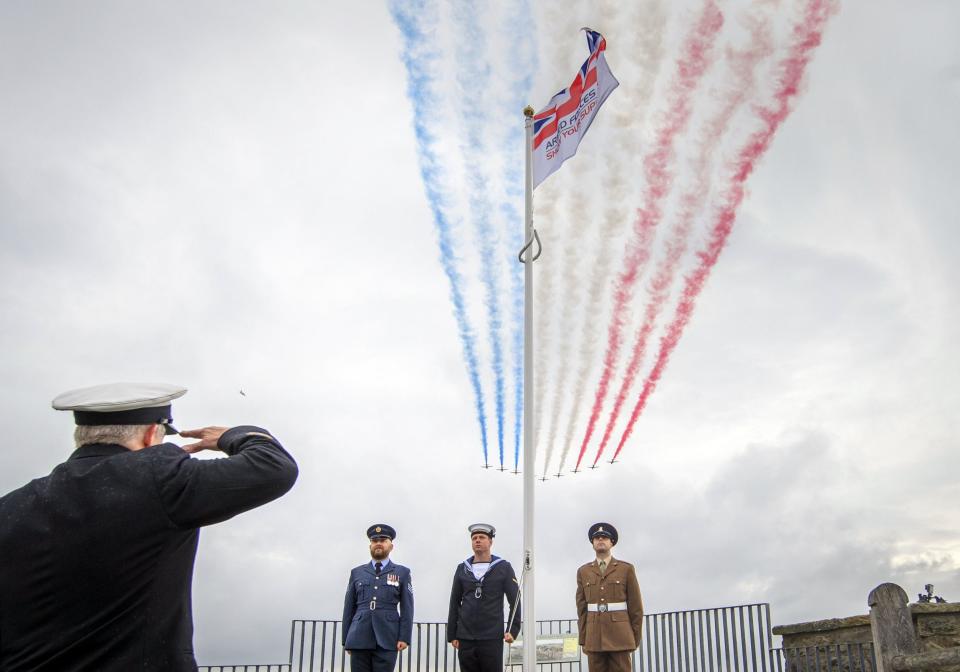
341;561;413;651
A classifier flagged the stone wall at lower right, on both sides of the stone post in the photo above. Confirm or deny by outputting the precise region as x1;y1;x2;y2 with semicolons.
773;602;960;672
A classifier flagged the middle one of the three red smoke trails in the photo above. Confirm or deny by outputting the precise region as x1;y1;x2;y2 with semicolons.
593;17;772;465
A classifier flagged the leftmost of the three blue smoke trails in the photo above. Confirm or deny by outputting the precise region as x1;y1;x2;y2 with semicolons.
390;0;488;465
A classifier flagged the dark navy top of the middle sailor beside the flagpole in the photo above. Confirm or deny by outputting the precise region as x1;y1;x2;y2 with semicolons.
447;555;520;642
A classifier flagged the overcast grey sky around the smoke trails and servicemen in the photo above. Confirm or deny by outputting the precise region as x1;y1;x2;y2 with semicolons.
0;0;960;664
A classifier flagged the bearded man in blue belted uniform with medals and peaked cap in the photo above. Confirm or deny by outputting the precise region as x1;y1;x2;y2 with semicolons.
342;524;413;672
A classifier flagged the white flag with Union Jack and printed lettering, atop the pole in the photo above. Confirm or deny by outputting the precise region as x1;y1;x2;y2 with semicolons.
533;28;620;188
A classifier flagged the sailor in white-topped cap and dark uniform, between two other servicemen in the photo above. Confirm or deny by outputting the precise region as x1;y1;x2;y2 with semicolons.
447;523;520;672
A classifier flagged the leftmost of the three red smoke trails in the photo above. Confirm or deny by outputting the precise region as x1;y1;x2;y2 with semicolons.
574;0;723;471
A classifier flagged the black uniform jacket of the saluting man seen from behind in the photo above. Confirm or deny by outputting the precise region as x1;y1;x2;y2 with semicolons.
0;426;297;672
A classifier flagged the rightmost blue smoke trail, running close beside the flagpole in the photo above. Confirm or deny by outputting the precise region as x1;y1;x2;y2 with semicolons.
500;0;543;471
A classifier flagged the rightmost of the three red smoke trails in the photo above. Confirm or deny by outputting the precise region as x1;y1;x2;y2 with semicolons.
613;0;834;459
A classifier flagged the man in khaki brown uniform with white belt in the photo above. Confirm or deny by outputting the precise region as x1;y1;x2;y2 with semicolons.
577;523;643;672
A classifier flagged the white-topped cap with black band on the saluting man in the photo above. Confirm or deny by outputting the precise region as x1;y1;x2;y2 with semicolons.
51;383;187;434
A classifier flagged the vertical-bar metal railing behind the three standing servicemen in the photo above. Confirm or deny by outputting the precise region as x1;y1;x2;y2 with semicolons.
289;603;776;672
